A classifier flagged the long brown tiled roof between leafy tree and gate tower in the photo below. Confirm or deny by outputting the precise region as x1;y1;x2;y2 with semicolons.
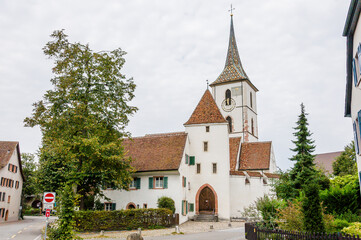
123;132;187;172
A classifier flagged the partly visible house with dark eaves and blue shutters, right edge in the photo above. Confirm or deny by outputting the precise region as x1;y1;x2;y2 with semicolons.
343;0;361;188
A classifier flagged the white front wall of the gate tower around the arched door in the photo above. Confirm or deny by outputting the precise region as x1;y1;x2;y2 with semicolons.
186;123;230;219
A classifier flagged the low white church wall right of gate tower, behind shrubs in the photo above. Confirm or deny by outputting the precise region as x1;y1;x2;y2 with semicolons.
230;175;273;218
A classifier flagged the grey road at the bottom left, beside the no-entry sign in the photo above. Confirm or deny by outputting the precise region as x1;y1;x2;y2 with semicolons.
0;216;55;240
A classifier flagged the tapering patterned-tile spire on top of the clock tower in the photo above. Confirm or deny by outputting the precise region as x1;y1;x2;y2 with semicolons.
211;13;248;86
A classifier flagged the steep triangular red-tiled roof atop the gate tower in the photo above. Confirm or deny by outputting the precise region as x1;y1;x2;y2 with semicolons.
184;89;227;125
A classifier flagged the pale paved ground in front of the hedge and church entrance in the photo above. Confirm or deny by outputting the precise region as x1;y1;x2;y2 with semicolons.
79;221;244;240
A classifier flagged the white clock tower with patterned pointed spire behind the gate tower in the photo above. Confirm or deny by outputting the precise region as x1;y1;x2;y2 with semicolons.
210;14;258;142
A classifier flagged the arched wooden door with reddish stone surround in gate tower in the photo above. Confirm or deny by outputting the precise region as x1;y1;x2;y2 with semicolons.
196;184;218;214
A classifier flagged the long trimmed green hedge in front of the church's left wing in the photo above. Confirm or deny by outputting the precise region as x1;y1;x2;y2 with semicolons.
75;208;174;232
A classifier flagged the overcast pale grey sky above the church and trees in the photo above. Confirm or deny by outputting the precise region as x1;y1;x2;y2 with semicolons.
0;0;352;169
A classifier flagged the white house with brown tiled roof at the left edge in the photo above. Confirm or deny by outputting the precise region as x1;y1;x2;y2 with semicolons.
0;141;24;223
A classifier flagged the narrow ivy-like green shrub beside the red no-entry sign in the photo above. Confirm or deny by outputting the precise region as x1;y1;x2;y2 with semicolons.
49;185;76;240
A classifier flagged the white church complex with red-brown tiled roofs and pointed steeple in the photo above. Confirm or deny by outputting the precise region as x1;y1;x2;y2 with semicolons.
102;15;278;223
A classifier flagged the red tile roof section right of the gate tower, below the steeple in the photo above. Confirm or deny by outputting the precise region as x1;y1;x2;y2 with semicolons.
239;142;272;170
